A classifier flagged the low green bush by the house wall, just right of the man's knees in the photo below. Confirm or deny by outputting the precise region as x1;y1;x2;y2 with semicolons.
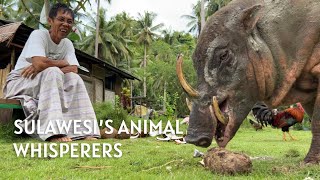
93;96;129;129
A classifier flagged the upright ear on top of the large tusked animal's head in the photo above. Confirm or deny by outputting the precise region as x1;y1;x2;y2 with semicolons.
241;4;262;32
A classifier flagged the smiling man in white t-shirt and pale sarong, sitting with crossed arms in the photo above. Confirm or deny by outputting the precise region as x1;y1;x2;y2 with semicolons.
4;3;100;142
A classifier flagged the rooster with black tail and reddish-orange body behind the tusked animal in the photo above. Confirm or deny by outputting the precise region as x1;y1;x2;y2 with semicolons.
252;103;304;141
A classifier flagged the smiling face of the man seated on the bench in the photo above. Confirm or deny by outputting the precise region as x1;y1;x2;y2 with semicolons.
49;10;74;43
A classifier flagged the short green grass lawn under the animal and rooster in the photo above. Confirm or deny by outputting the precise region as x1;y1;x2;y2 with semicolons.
0;124;320;179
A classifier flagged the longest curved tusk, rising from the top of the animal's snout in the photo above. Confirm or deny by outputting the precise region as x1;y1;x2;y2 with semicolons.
176;55;199;98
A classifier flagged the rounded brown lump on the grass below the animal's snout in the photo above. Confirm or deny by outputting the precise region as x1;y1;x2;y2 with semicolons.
204;148;252;175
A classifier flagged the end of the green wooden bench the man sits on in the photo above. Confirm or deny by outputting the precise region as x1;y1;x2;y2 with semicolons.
0;99;24;124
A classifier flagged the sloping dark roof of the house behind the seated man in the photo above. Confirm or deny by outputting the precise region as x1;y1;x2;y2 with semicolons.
0;19;140;81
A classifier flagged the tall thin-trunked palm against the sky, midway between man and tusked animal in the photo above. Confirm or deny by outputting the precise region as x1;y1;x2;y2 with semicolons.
137;11;164;97
